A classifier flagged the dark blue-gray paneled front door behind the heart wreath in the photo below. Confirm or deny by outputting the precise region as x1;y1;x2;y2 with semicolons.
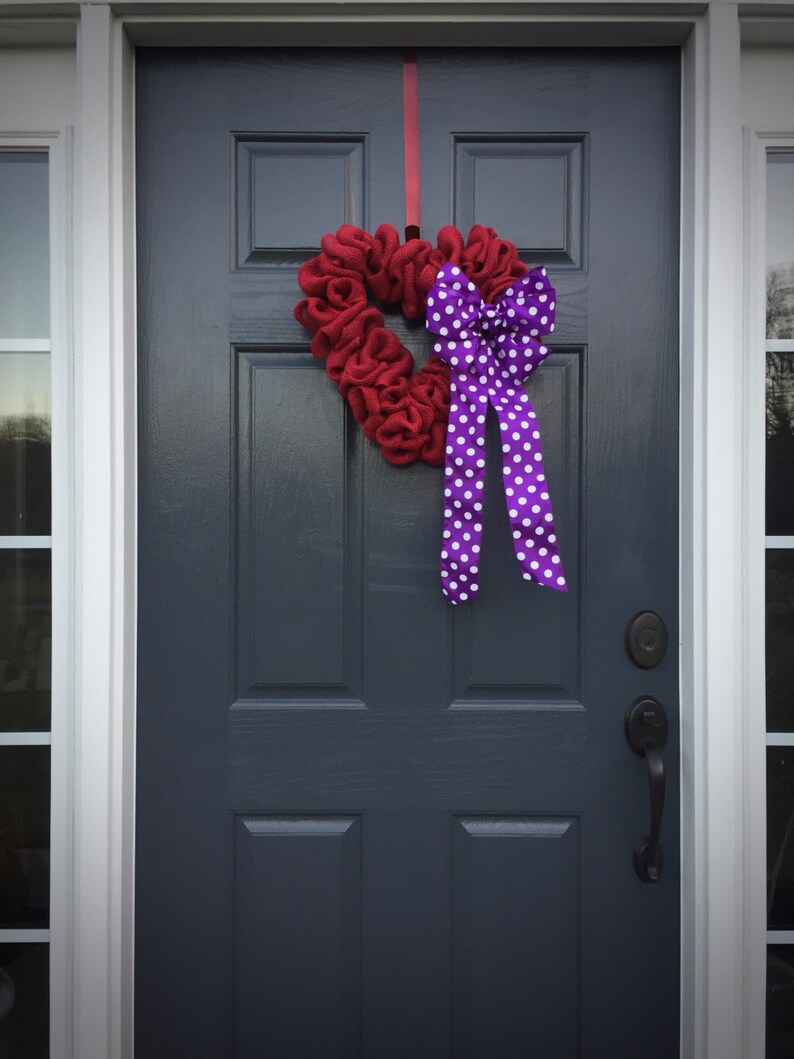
136;49;679;1059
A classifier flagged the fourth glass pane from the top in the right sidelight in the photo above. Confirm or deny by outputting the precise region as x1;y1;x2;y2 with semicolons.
766;747;794;930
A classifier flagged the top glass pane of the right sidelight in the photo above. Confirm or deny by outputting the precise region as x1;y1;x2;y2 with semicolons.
766;151;794;338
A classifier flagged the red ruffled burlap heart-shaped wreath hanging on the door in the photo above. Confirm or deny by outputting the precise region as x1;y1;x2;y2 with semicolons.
294;225;527;465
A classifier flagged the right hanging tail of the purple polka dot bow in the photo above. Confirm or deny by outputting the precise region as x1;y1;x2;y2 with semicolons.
491;385;567;592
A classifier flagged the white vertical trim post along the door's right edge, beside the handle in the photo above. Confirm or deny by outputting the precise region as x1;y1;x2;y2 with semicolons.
682;3;758;1059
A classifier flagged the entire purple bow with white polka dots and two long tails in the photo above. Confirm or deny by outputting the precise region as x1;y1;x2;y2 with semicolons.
427;264;567;604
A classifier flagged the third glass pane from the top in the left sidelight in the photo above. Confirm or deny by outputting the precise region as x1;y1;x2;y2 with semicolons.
0;549;52;732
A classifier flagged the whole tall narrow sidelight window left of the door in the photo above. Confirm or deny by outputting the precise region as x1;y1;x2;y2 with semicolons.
0;149;52;1059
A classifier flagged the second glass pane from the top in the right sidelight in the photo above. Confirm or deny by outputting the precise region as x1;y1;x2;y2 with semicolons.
766;353;794;535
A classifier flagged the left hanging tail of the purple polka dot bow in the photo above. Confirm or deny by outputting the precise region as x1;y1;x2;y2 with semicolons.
441;372;488;604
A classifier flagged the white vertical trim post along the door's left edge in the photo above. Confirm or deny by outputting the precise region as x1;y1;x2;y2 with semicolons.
72;3;134;1059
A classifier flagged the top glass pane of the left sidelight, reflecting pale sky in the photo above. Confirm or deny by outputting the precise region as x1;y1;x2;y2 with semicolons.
0;151;50;339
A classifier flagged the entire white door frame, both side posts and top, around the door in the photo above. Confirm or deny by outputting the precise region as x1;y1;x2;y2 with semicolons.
37;0;770;1059
